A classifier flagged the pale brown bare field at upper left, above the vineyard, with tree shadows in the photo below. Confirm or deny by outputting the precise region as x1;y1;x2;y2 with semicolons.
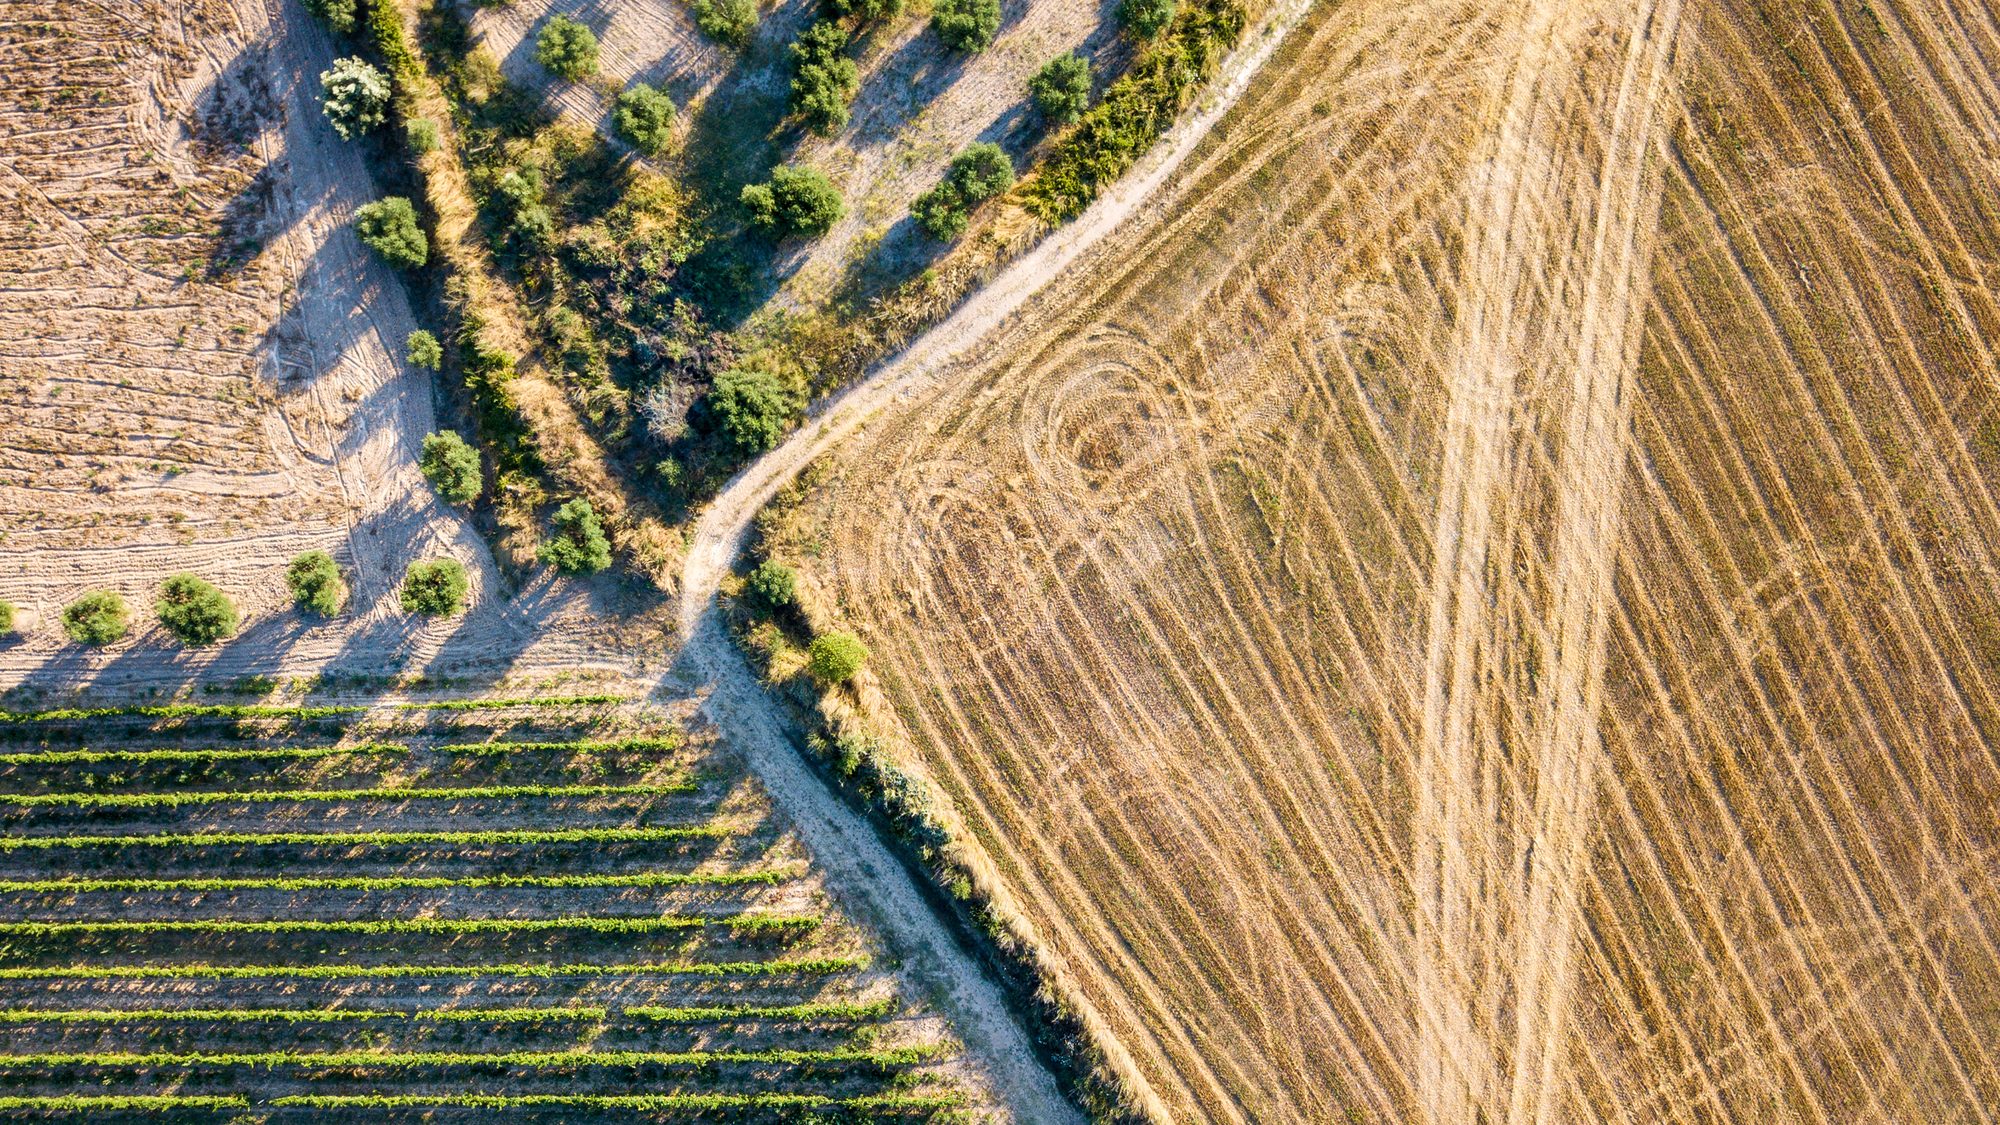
0;0;636;687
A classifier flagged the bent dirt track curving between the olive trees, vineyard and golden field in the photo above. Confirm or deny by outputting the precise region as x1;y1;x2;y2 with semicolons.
680;0;1310;1125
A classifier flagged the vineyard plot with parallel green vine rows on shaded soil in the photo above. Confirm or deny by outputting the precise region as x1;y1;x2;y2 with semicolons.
0;705;982;1121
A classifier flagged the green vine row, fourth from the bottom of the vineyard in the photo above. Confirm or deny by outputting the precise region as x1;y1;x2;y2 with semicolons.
0;957;868;981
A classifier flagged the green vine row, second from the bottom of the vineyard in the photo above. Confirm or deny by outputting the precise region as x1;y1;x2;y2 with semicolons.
0;1045;944;1071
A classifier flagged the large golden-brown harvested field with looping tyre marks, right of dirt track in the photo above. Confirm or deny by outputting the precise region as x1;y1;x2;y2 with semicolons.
770;0;2000;1125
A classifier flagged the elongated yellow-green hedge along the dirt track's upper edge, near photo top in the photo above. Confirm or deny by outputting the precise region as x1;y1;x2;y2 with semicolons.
1022;0;1244;222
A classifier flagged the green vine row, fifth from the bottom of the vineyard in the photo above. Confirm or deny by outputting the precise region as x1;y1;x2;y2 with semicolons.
0;915;820;937
